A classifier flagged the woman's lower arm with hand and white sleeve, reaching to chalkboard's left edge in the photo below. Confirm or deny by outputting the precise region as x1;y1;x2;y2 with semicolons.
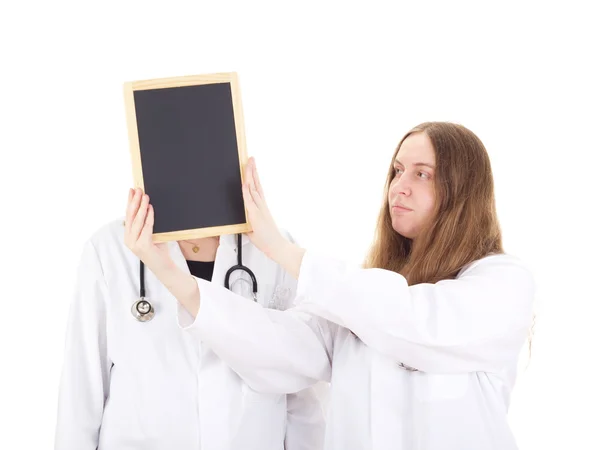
125;189;333;393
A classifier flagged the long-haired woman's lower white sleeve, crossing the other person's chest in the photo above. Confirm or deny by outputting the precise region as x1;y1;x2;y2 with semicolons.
178;278;333;394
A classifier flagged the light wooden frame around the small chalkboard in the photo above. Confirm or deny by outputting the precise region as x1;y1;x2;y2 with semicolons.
123;72;252;242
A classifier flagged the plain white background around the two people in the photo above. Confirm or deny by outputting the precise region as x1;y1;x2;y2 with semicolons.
0;0;600;450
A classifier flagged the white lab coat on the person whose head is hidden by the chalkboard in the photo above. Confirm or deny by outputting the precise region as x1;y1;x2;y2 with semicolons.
55;219;326;450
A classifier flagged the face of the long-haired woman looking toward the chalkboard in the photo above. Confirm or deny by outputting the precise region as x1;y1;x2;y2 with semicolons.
388;133;435;239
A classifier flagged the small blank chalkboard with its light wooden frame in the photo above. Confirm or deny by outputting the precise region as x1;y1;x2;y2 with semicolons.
124;73;251;242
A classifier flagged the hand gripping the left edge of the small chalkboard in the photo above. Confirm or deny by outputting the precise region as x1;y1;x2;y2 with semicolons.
125;188;173;274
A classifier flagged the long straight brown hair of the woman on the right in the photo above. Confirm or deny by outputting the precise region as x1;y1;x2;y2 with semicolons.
364;122;504;285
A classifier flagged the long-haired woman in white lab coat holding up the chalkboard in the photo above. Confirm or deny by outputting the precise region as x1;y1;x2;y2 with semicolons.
126;122;534;450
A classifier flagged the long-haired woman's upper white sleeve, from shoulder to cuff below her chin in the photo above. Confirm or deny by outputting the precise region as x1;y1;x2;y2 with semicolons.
298;250;535;373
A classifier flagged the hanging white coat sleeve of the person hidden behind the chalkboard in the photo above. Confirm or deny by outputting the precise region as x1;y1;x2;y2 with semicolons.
55;241;112;450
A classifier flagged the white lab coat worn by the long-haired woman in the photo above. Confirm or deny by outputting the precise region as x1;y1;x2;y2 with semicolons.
178;250;534;450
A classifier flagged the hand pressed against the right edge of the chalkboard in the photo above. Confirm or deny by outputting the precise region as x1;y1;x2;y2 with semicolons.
242;158;287;258
